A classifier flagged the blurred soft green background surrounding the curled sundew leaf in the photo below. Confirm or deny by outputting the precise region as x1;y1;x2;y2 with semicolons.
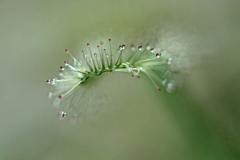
0;0;240;160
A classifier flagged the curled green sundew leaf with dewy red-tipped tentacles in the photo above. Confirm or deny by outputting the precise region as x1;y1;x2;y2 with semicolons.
46;39;180;122
